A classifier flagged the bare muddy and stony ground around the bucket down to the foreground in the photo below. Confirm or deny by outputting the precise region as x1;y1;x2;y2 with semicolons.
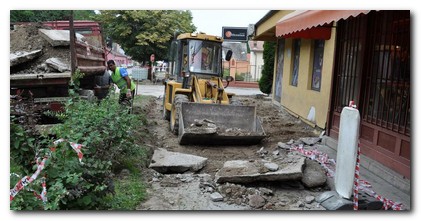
133;96;328;210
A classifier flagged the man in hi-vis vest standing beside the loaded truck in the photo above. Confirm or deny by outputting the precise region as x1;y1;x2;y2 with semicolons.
107;60;136;106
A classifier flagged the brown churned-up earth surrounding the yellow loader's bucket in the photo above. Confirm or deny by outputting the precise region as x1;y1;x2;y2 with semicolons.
140;96;318;175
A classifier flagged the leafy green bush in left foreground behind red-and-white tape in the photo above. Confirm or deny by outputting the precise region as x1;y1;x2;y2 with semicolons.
10;92;148;210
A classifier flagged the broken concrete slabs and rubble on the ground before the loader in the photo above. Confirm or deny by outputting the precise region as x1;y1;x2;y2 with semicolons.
149;138;331;210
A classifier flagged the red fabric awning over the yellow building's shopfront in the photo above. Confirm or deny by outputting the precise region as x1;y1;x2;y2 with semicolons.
276;10;370;40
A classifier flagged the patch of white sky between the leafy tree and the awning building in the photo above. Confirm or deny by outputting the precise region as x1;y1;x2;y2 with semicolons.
191;9;269;36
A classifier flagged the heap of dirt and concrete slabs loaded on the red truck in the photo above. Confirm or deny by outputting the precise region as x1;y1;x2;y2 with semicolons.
10;23;83;74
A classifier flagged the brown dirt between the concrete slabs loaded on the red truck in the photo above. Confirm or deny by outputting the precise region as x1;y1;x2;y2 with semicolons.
10;23;70;74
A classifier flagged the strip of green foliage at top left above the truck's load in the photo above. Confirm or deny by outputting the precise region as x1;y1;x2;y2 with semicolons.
10;10;95;22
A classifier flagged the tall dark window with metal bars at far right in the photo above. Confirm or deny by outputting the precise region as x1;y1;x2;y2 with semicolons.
362;11;411;135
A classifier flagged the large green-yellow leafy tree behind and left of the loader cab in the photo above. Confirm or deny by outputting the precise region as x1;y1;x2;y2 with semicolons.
97;10;196;61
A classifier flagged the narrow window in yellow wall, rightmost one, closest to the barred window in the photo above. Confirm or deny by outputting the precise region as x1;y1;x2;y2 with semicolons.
311;40;325;91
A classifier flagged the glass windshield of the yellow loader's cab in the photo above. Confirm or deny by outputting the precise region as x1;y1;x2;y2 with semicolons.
189;40;221;75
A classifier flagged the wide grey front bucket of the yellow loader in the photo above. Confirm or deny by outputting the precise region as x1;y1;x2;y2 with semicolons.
178;102;266;145
